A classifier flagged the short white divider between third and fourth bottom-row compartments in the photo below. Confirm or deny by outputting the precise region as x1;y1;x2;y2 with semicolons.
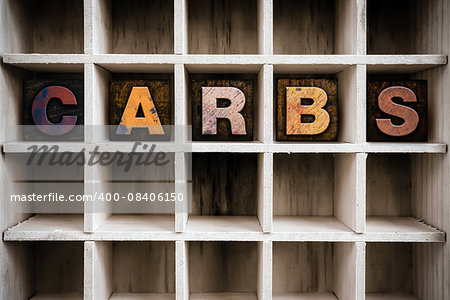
256;241;272;300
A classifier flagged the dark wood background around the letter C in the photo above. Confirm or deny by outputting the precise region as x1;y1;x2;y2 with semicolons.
23;79;84;141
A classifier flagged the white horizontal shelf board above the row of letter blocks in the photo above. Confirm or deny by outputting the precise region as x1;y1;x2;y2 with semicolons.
3;54;447;74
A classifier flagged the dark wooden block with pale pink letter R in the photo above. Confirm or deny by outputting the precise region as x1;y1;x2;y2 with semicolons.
191;75;256;141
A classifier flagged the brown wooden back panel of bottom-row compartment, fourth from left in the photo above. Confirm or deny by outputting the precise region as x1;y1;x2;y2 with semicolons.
272;242;334;294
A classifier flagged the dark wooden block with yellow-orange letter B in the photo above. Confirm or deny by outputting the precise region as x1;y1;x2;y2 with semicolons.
276;78;338;141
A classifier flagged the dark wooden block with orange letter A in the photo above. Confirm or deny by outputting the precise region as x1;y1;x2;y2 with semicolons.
109;79;173;141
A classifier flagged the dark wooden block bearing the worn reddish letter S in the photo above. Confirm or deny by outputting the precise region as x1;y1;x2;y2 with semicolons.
367;80;428;142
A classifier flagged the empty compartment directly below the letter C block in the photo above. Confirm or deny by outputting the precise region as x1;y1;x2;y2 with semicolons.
4;152;84;218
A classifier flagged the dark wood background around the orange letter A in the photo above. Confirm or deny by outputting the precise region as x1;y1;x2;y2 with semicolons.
109;78;173;141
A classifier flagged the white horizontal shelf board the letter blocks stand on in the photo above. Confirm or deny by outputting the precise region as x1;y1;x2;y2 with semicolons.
3;141;447;153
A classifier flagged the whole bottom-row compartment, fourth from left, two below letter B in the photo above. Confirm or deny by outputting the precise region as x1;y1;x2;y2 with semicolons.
272;242;356;300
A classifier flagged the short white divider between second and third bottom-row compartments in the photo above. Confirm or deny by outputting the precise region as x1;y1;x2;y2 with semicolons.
175;241;189;300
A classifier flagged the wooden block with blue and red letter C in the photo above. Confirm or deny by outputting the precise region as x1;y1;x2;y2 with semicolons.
23;79;84;141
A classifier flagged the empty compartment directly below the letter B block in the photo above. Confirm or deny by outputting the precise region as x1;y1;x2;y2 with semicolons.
273;154;355;232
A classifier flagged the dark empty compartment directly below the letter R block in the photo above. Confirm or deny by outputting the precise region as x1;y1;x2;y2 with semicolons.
187;153;260;231
